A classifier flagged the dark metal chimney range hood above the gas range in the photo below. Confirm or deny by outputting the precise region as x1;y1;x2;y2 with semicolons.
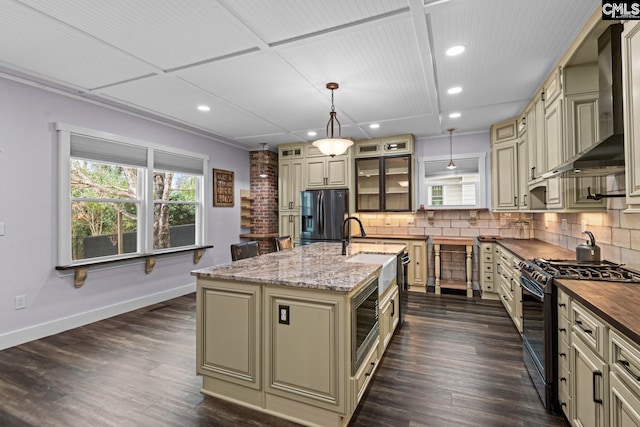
542;24;624;178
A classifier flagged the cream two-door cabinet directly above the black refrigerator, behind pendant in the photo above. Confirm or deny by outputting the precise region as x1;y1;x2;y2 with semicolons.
304;144;351;189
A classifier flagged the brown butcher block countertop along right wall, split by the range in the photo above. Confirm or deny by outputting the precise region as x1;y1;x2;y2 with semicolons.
481;239;640;345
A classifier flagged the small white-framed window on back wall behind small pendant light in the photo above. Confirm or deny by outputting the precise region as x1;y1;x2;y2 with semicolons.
419;153;486;209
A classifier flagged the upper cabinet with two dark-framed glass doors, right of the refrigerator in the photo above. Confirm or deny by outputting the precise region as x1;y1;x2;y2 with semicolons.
355;135;413;212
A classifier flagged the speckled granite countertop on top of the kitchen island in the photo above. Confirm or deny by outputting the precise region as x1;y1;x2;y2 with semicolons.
191;242;406;293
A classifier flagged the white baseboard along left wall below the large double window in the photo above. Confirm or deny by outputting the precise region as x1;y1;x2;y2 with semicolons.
0;282;196;350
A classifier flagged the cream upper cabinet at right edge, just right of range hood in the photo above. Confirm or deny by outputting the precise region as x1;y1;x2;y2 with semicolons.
622;21;640;212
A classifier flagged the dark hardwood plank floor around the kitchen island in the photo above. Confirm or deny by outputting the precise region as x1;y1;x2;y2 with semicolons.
0;293;568;427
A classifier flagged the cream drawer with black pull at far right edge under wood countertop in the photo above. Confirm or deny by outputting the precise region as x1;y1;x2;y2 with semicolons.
609;329;640;396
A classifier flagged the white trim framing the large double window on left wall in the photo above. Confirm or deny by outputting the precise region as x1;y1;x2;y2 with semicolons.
55;123;210;266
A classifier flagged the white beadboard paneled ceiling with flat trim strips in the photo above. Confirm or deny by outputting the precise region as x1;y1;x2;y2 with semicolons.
0;0;600;149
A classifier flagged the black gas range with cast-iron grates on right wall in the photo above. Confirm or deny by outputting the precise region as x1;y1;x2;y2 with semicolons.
519;258;640;412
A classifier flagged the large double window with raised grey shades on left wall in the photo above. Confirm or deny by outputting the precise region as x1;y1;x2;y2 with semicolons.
57;124;207;265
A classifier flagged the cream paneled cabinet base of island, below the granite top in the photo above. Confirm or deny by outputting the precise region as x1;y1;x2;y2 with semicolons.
196;277;392;427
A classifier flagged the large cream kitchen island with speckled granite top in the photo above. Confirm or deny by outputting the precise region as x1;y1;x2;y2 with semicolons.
192;243;405;426
